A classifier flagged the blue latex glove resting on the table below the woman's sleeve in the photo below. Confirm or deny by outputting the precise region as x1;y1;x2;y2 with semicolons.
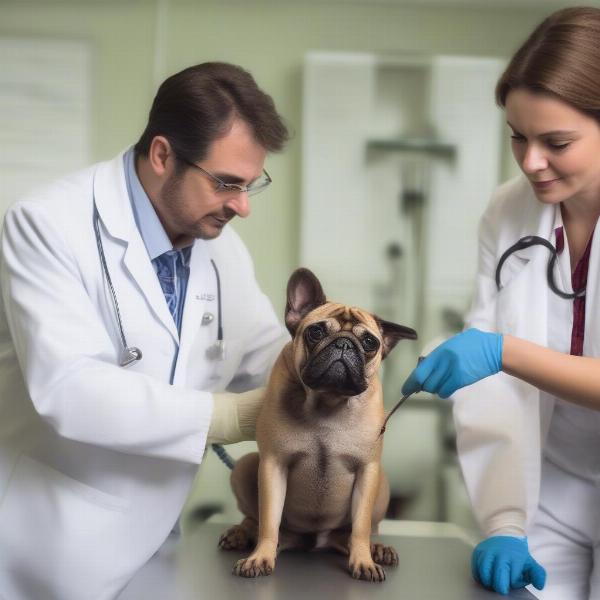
471;535;546;595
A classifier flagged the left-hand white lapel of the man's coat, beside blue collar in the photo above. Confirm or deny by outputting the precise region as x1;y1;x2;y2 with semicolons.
93;154;179;342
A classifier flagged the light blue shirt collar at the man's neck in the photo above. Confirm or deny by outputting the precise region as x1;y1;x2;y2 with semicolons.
123;147;173;260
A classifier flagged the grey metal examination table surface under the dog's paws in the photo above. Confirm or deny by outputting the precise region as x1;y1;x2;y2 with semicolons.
119;523;534;600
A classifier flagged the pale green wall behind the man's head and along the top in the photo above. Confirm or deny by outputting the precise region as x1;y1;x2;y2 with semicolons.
0;0;551;314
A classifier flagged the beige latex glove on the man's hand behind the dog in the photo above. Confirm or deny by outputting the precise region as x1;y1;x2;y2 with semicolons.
206;387;265;444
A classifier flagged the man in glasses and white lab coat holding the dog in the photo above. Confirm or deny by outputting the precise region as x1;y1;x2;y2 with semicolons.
0;63;287;600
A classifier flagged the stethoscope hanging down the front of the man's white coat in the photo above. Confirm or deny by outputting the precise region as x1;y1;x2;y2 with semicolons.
93;198;225;367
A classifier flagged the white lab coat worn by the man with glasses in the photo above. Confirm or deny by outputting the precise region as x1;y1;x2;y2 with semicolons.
0;156;287;600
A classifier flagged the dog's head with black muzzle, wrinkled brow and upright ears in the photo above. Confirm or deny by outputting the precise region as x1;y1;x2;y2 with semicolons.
285;269;417;396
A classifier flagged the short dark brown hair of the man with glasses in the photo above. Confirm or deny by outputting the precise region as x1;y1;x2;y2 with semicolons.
135;62;289;167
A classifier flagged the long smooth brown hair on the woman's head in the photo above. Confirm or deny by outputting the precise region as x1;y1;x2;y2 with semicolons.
496;7;600;121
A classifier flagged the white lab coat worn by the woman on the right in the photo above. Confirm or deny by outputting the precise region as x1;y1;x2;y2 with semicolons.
453;176;600;536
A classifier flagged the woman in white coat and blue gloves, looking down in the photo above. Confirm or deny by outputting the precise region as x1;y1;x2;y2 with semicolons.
403;8;600;600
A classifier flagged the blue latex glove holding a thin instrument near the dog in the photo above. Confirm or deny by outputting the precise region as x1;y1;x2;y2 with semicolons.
402;329;503;398
